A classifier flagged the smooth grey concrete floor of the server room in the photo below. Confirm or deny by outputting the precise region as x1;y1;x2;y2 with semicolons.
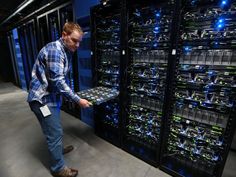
0;82;236;177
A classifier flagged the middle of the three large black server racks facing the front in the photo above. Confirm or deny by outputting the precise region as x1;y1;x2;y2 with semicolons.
122;0;178;166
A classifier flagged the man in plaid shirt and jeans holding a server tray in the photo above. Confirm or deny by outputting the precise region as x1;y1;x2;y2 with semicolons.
28;22;91;177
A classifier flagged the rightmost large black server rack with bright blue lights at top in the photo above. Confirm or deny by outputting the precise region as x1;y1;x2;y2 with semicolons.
161;0;236;177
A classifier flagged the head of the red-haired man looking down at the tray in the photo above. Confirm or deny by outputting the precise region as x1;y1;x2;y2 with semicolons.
62;22;84;52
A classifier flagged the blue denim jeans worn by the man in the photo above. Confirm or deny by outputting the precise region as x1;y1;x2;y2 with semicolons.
29;101;65;172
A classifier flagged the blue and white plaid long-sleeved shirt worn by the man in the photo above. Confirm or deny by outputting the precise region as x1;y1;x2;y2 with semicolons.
27;38;80;106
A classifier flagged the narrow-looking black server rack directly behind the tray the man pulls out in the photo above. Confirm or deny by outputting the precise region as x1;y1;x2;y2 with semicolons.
91;2;122;146
